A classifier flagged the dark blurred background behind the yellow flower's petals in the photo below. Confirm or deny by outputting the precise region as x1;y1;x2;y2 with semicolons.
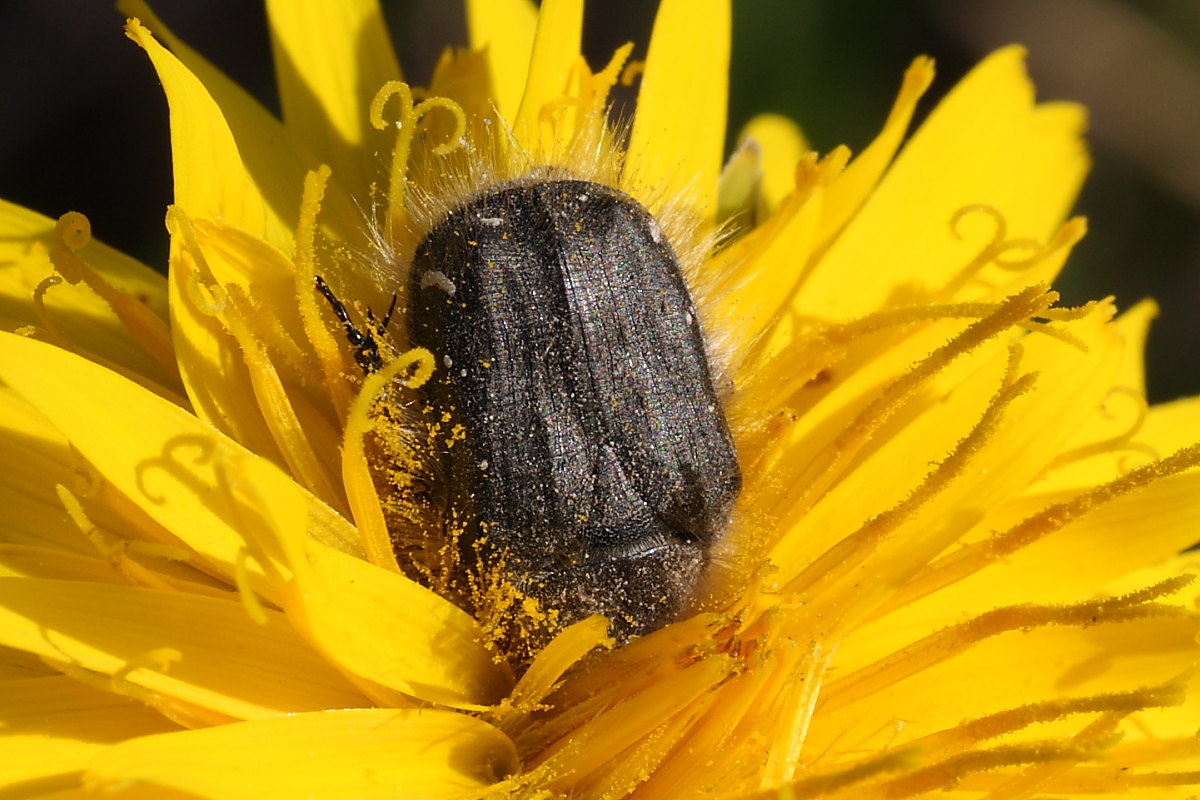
0;0;1200;401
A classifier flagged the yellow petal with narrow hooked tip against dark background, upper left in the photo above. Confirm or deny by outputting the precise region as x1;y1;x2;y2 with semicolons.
127;19;285;242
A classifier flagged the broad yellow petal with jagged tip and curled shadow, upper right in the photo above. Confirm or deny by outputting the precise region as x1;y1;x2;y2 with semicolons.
797;48;1086;320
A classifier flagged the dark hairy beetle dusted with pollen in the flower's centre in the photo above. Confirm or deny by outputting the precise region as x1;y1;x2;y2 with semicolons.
407;178;742;640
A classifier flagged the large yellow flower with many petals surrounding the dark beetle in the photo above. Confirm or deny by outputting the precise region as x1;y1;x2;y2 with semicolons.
0;0;1200;799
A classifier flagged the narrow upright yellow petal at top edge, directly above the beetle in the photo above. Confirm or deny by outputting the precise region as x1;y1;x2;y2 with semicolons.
512;0;583;152
